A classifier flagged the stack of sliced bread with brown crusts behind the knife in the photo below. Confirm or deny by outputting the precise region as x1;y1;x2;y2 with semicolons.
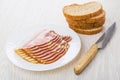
63;1;105;35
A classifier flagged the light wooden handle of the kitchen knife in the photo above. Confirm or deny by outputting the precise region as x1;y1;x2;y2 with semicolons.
74;44;98;74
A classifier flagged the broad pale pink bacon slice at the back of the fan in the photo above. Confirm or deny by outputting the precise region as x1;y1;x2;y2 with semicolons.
23;29;58;48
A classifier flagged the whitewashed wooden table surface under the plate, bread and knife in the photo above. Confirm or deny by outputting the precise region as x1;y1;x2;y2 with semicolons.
0;0;120;80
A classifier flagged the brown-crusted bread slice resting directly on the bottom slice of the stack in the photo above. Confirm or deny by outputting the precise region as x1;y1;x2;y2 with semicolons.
67;18;105;29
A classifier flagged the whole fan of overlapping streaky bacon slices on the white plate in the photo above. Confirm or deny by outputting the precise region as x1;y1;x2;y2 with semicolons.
15;29;72;64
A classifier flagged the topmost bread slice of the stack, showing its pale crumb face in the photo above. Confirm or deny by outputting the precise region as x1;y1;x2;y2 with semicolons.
63;1;103;20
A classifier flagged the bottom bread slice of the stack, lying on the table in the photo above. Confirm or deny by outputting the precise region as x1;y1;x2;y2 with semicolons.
69;25;103;35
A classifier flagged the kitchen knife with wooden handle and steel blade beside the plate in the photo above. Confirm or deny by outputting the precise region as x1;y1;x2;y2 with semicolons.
74;22;116;74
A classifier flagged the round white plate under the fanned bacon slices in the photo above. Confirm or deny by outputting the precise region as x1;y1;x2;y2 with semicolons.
5;25;81;71
